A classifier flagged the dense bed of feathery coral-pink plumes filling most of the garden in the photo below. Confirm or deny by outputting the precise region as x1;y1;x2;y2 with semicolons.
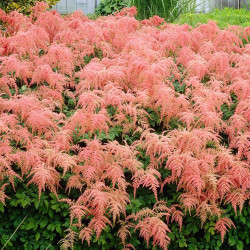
0;3;250;249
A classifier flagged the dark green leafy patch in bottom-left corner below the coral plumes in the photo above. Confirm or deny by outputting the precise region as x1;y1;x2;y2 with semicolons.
0;183;70;250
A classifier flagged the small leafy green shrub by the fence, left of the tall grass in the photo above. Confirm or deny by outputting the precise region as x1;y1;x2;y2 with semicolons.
95;0;127;16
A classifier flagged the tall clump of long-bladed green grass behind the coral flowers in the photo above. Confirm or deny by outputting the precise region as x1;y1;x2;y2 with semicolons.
129;0;196;22
